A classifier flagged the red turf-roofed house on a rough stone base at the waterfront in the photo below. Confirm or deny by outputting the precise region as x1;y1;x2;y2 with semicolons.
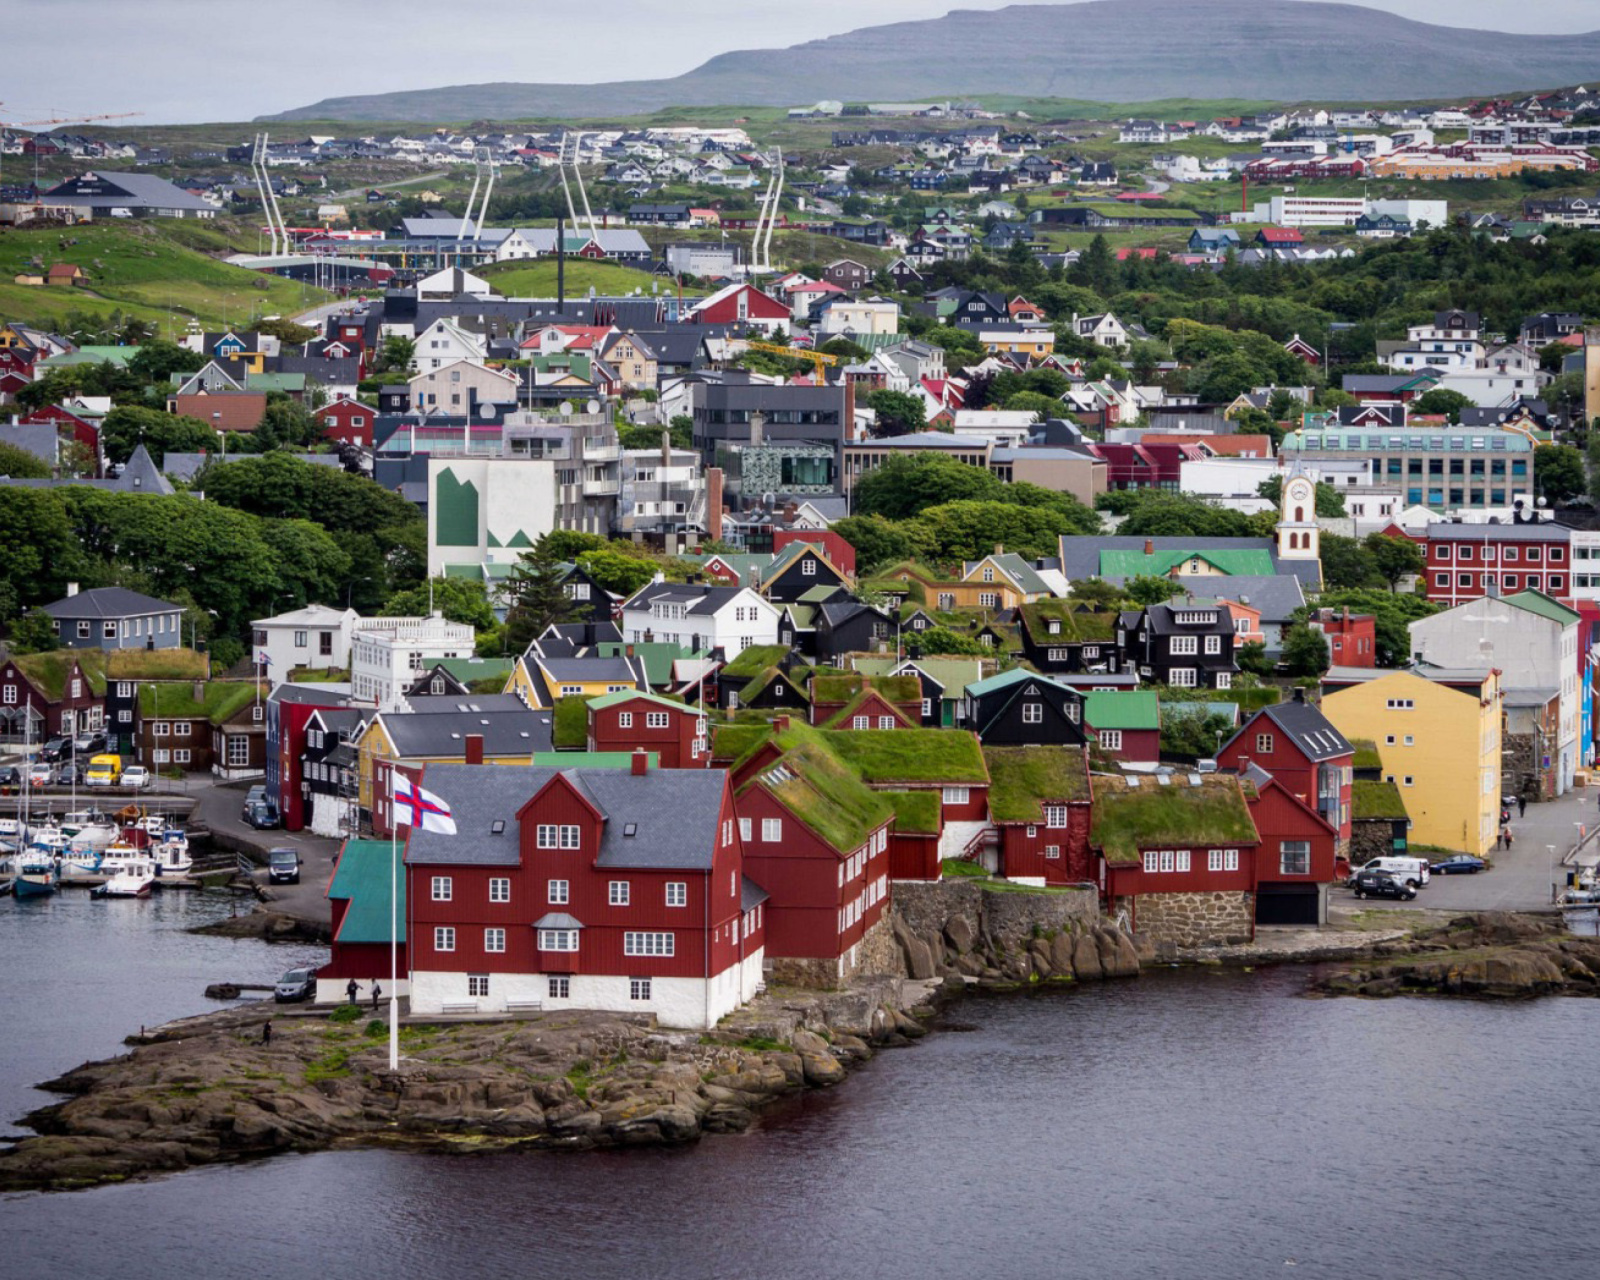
1090;774;1261;947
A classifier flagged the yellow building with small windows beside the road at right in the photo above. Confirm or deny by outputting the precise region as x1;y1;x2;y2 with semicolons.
1322;667;1504;856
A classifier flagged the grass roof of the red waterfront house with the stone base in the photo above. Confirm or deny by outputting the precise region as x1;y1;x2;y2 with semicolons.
1090;774;1258;864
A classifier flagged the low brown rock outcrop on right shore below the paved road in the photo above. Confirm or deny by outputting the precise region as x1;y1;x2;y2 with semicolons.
1312;912;1600;1000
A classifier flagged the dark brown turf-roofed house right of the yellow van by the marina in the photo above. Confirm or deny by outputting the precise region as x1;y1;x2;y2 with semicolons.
134;680;267;778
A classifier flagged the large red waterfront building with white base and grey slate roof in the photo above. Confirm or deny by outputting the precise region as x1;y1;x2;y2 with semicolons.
405;754;766;1030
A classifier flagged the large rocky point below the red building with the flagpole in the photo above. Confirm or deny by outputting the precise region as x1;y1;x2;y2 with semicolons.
0;979;938;1192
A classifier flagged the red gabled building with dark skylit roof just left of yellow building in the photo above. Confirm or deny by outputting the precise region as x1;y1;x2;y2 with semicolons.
1216;690;1355;851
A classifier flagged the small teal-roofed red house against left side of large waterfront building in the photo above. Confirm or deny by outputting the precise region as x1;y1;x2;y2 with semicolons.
317;840;410;1005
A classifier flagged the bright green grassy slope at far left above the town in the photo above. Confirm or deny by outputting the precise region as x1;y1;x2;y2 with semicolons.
0;219;331;336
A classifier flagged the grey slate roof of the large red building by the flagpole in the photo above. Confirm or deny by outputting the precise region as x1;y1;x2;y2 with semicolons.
406;765;726;870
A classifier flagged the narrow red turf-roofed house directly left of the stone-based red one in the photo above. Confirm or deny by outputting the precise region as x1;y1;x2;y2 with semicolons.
984;747;1096;885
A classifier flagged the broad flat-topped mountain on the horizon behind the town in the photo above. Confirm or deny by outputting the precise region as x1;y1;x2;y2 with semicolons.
264;0;1600;122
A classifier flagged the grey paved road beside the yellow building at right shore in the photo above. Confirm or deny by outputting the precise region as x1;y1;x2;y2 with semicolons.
1333;790;1600;912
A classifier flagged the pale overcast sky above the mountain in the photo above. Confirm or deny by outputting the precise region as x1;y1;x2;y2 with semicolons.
9;0;1600;123
